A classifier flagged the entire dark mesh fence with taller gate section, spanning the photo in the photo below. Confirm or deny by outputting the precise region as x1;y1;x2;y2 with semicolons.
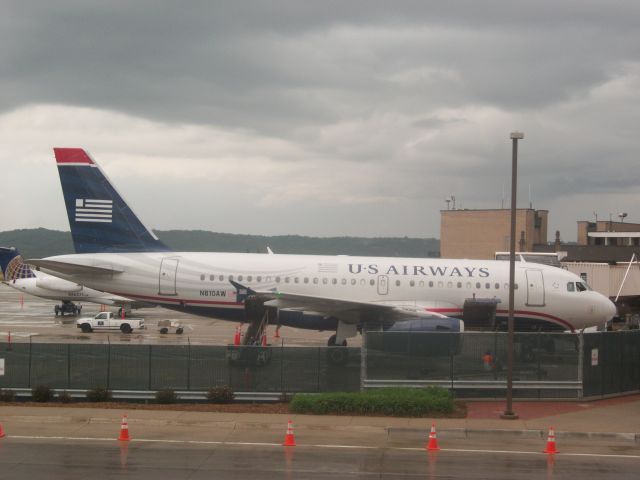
0;331;640;398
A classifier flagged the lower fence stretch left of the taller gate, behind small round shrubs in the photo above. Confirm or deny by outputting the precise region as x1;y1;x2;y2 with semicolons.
0;342;361;393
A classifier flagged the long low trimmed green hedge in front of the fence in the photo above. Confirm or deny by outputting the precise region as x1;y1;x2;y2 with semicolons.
289;387;454;417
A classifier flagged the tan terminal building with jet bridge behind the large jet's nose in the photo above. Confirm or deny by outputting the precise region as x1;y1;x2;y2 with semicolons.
440;208;640;316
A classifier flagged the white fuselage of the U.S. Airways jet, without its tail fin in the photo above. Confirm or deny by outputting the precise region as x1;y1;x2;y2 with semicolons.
38;252;615;330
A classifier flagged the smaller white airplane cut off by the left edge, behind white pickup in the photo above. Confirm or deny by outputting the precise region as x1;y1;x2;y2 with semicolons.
0;247;138;316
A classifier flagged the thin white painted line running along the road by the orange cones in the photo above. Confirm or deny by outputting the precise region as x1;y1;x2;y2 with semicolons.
5;435;640;460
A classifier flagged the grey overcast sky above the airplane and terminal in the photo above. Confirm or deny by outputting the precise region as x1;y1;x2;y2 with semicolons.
0;0;640;240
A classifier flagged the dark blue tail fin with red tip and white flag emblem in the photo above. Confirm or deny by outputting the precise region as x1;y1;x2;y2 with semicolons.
53;148;169;253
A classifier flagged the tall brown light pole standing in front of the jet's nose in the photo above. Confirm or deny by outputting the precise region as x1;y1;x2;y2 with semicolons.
500;132;524;420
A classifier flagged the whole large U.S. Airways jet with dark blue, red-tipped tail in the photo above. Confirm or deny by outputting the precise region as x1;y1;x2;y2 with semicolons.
29;148;616;345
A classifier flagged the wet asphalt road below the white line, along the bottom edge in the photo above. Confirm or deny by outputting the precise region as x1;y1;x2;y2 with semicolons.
0;438;640;480
